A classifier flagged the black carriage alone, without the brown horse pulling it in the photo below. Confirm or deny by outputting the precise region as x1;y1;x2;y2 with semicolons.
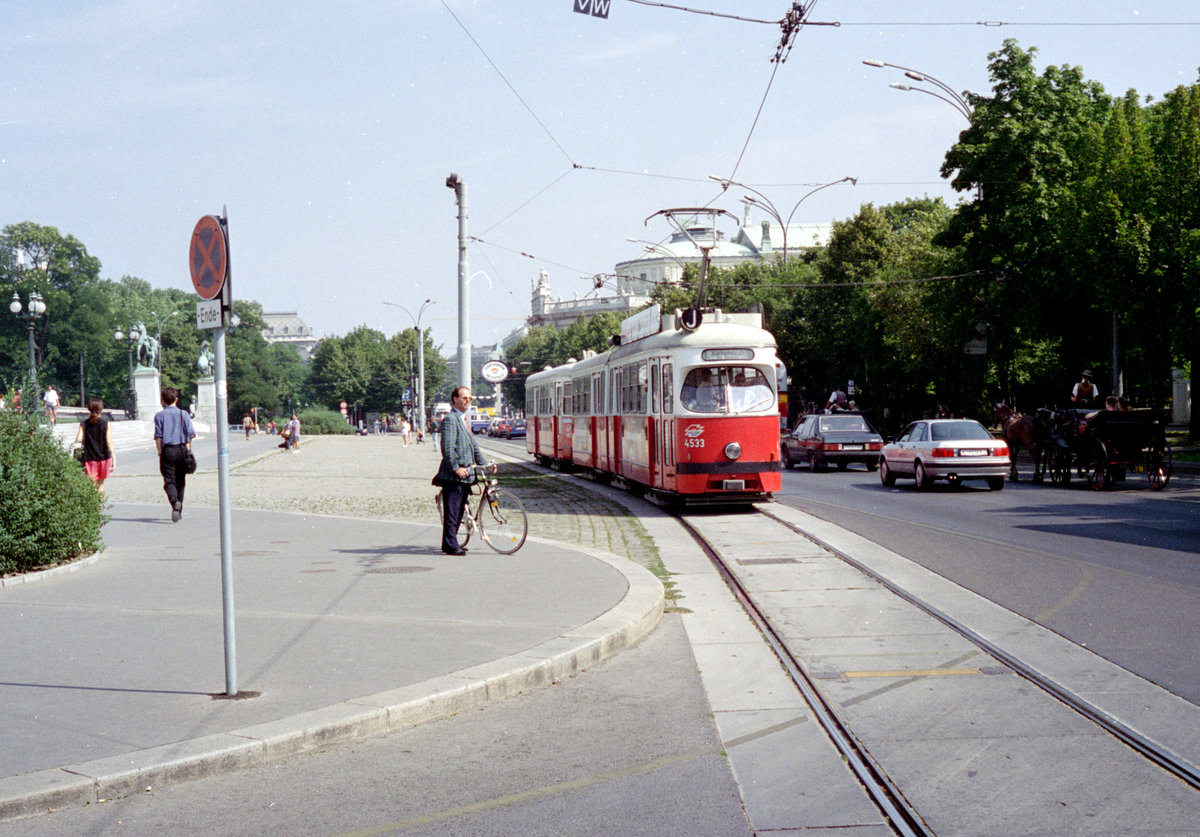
1042;410;1171;490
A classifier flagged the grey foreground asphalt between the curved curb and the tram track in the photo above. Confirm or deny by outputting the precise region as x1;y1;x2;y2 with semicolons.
14;614;750;837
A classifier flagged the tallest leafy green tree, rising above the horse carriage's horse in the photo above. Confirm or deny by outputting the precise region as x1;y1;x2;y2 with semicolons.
940;40;1111;400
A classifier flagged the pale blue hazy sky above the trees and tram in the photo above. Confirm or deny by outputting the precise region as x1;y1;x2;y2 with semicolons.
0;0;1200;356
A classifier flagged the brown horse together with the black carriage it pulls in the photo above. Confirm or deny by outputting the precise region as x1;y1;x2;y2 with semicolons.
995;404;1171;490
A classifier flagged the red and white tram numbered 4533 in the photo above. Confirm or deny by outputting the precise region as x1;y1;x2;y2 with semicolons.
526;306;781;504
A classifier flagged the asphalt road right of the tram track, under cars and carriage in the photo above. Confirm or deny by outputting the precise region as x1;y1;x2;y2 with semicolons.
776;455;1200;704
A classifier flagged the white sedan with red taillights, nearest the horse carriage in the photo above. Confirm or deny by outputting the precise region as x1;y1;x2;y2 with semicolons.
880;419;1012;492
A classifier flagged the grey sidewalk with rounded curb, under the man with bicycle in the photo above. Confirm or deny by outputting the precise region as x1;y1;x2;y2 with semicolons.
0;436;664;820
